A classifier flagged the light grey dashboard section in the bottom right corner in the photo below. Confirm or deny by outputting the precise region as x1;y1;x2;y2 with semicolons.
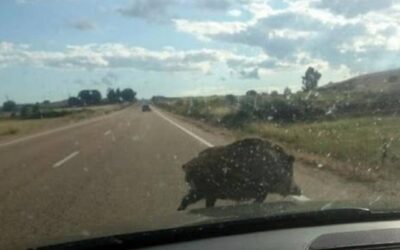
150;220;400;250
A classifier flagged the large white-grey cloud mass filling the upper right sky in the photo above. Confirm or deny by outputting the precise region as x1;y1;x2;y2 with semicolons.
174;0;400;72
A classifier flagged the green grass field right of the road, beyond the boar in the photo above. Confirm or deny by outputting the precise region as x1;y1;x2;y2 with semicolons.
244;117;400;169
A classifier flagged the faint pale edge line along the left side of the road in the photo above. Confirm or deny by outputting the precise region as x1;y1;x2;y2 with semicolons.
0;110;124;148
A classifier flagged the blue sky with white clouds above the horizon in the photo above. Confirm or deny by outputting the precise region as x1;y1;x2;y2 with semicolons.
0;0;400;103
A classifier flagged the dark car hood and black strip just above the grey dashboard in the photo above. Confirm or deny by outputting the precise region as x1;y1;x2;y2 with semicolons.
35;200;400;249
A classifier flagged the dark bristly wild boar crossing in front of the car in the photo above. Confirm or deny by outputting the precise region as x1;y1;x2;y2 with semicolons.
178;138;301;210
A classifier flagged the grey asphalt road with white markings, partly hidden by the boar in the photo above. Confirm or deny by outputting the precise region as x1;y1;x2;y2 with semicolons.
0;107;378;249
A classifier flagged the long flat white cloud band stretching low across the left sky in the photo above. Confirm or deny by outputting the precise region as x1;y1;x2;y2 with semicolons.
0;42;279;75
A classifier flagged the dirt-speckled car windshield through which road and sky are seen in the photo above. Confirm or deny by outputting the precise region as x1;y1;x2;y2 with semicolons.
0;0;400;249
